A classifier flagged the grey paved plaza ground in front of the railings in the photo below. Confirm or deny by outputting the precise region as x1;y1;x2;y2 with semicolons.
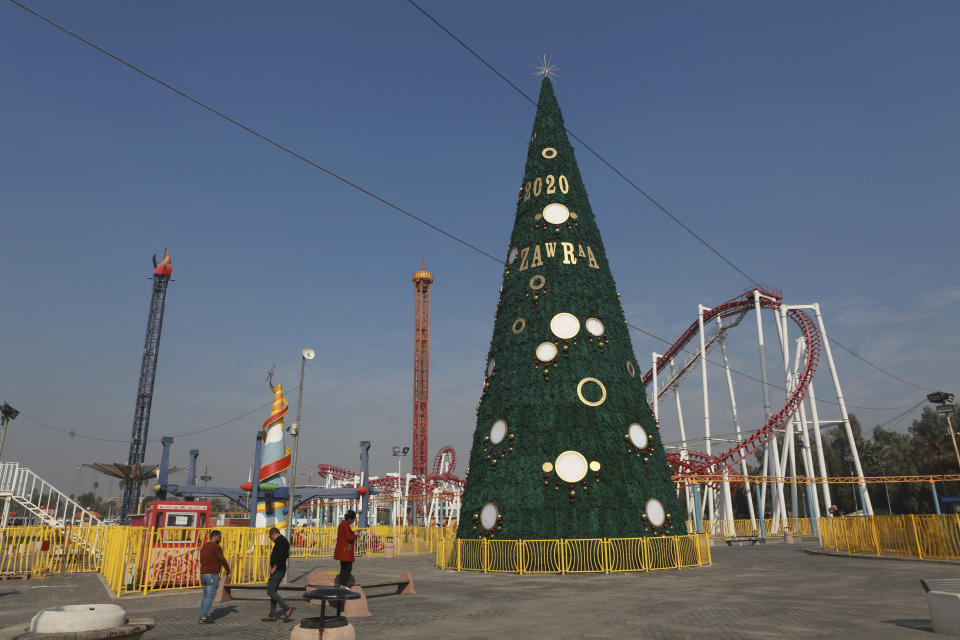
0;542;960;640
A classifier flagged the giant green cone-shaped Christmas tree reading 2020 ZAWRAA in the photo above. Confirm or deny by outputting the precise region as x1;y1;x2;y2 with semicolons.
457;76;686;540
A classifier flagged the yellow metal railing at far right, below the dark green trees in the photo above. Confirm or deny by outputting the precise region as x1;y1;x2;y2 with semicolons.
819;514;960;560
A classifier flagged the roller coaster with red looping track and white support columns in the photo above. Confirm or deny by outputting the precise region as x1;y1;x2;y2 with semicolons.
643;287;873;536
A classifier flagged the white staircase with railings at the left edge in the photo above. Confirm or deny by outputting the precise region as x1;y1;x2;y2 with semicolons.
0;462;103;555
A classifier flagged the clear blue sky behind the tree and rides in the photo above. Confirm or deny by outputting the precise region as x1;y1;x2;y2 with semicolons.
0;0;960;498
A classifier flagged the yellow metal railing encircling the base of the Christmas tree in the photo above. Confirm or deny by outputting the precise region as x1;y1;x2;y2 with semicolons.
435;534;712;574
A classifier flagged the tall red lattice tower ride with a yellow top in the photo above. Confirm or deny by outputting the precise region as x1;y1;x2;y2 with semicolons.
413;257;433;479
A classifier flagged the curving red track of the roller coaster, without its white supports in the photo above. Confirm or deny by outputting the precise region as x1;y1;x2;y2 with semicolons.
643;288;823;482
